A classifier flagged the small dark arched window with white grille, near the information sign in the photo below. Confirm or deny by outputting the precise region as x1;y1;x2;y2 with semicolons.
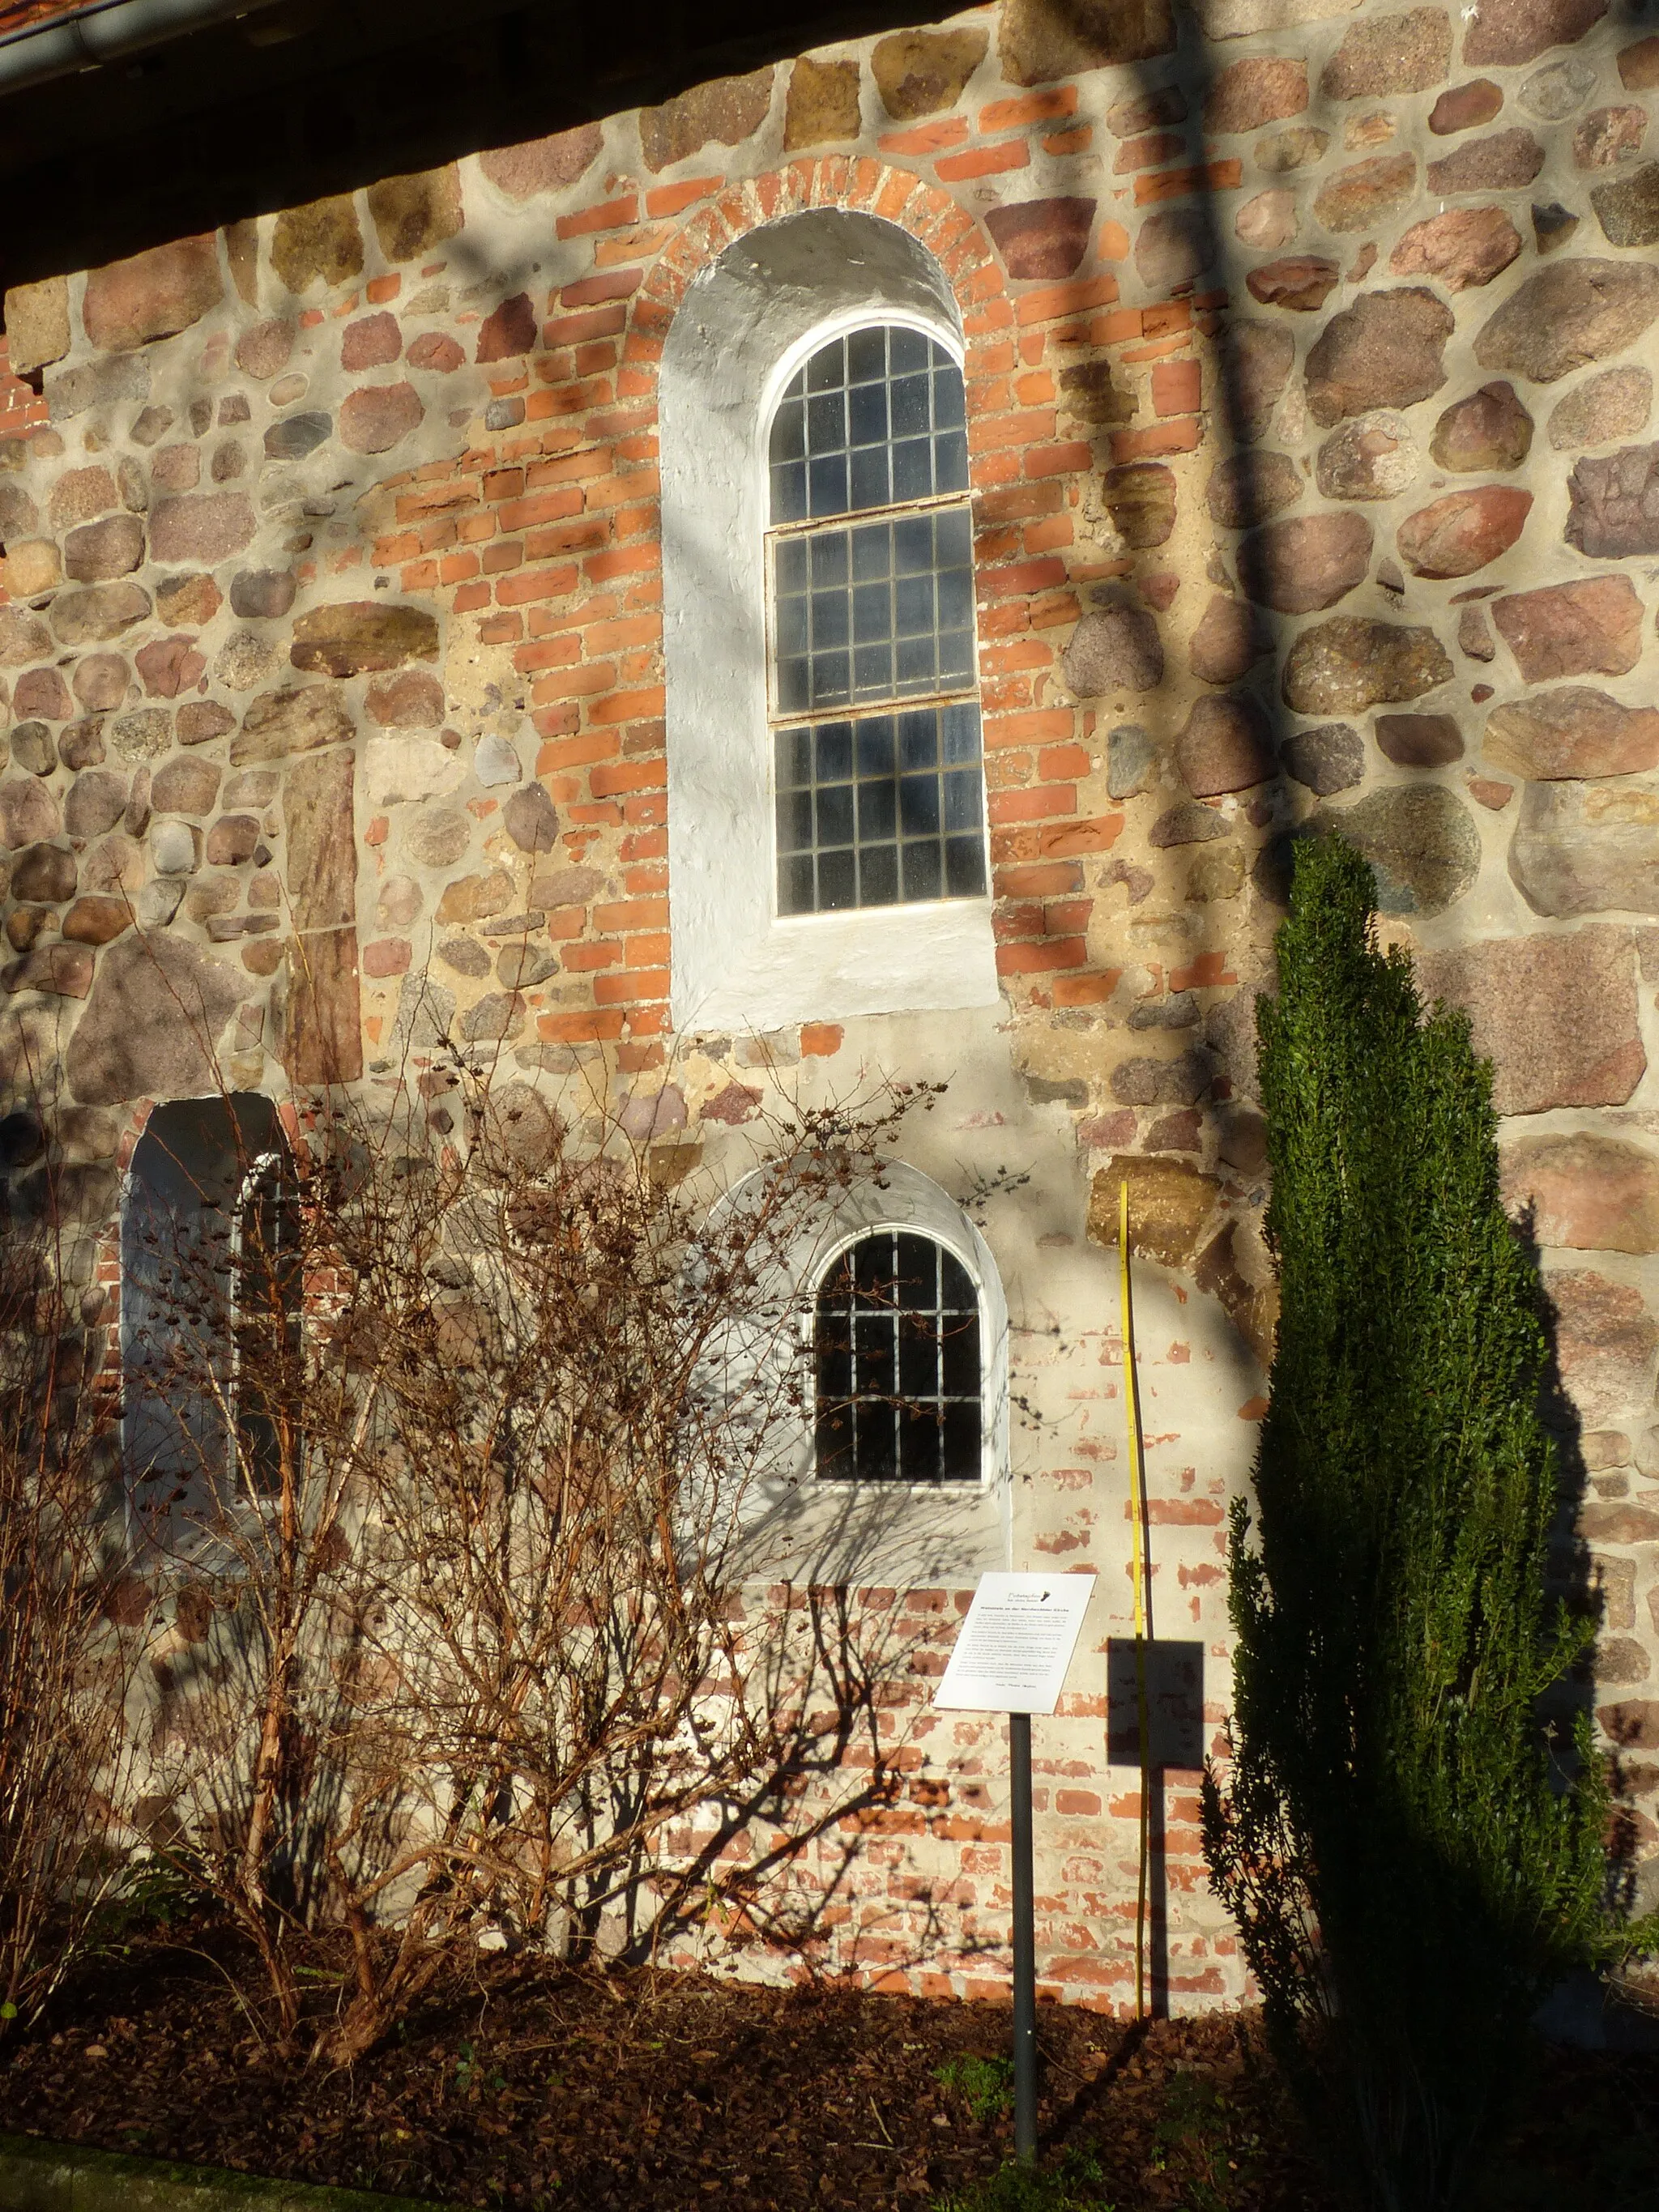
814;1230;982;1482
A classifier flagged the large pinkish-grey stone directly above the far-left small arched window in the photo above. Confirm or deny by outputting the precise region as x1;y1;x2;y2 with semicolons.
64;931;241;1106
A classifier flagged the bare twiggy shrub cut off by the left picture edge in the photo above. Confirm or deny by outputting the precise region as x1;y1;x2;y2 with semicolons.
0;1108;137;2033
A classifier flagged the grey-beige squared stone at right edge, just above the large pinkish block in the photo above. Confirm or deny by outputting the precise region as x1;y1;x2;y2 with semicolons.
1508;778;1659;916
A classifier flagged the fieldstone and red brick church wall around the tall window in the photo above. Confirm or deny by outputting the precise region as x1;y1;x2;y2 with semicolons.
0;0;1659;2006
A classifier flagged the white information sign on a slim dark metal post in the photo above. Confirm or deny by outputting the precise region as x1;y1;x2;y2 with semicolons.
933;1573;1095;2166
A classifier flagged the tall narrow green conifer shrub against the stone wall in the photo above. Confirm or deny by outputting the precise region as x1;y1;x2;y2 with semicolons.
1203;838;1645;2212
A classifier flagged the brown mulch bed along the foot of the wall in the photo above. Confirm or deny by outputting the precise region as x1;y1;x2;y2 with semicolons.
0;1931;1659;2212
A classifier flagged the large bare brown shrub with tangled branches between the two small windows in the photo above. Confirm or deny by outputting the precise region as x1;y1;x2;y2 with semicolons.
130;1044;937;2060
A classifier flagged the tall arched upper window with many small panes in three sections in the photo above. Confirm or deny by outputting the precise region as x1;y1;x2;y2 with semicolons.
770;325;987;914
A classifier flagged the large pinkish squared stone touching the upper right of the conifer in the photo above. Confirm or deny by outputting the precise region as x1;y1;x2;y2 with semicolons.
1418;923;1648;1115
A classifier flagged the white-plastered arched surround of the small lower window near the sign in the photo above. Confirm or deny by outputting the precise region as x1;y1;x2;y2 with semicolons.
727;1161;1013;1588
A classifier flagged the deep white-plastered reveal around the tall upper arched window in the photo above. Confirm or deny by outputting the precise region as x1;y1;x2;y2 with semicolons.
659;210;998;1031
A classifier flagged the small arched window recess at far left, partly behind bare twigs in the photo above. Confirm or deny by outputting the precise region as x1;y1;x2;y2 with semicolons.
122;1093;299;1526
